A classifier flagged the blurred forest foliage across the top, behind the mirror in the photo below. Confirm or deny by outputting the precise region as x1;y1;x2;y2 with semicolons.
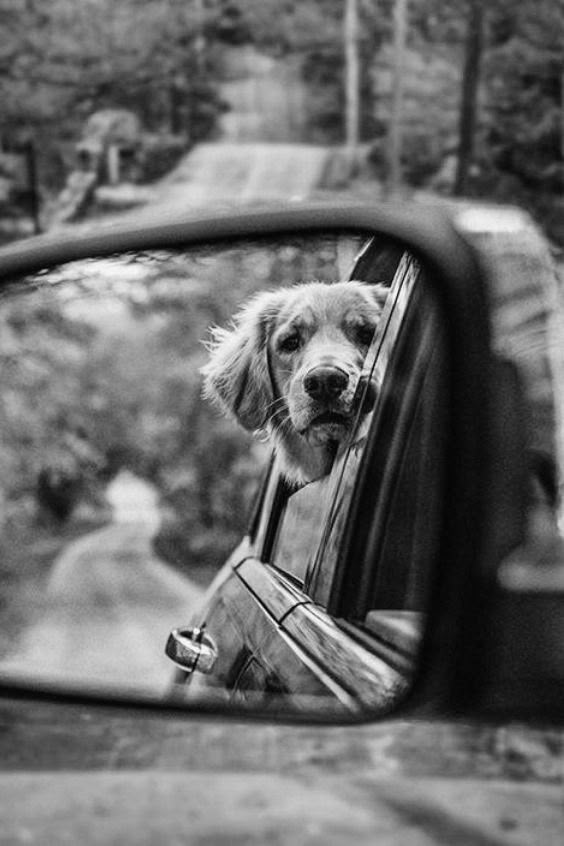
0;0;564;225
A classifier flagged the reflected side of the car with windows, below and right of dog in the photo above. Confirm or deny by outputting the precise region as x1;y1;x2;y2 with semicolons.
177;247;450;710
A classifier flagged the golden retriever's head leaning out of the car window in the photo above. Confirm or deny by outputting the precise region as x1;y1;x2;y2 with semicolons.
202;282;388;483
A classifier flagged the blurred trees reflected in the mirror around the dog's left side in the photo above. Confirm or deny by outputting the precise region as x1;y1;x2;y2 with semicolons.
0;235;358;584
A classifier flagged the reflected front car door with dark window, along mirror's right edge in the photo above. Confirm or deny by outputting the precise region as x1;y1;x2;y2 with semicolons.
266;248;448;708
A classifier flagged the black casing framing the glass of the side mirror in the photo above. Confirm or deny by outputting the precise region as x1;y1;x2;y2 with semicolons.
0;205;552;722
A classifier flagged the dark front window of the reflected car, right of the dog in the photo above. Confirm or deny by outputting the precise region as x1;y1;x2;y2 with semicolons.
360;298;447;652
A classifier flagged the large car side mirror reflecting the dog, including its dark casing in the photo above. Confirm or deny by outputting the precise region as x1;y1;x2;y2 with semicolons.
0;202;564;722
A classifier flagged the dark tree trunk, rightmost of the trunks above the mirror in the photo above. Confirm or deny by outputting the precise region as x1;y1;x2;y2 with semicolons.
453;0;484;195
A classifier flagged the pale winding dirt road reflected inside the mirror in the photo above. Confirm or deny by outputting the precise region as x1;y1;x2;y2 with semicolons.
0;473;201;693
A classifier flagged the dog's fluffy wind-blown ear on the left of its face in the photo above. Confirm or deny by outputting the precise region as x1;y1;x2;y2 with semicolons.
201;292;281;431
